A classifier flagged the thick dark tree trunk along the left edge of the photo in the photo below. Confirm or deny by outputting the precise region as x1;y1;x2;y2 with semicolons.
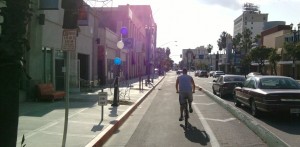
0;0;32;147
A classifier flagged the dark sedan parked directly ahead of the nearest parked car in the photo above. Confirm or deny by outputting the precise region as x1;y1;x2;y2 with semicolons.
212;75;246;98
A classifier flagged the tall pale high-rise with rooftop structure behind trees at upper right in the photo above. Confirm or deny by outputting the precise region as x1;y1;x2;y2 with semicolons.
233;3;268;38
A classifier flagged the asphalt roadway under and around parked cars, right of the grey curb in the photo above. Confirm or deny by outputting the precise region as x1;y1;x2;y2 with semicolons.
195;73;300;147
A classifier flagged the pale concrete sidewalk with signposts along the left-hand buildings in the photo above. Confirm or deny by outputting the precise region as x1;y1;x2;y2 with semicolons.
17;76;164;147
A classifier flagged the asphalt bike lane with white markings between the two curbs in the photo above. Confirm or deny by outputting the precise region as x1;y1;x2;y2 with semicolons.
104;72;267;147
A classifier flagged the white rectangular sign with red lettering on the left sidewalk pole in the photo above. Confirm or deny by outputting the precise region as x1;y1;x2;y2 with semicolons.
61;29;77;51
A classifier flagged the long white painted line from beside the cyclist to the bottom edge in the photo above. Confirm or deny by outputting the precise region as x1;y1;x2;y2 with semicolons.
194;106;220;147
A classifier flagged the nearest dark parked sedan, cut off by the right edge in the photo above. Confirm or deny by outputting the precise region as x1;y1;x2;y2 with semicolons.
234;76;300;116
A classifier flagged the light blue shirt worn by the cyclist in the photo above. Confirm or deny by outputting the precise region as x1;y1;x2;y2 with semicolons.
177;74;192;92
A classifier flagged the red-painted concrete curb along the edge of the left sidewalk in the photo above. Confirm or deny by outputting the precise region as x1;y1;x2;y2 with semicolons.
86;77;165;147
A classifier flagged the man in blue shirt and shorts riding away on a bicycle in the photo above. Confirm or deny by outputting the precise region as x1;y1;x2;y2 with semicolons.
176;68;195;121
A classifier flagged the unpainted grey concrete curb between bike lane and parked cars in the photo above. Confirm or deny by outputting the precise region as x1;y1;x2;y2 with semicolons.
196;85;290;147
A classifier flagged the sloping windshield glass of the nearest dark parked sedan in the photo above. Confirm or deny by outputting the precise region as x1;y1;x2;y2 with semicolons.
259;78;300;89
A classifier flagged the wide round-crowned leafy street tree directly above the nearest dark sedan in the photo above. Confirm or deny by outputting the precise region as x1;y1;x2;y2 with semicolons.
249;46;272;73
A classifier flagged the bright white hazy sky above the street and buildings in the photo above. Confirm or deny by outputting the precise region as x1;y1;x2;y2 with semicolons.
87;0;300;63
